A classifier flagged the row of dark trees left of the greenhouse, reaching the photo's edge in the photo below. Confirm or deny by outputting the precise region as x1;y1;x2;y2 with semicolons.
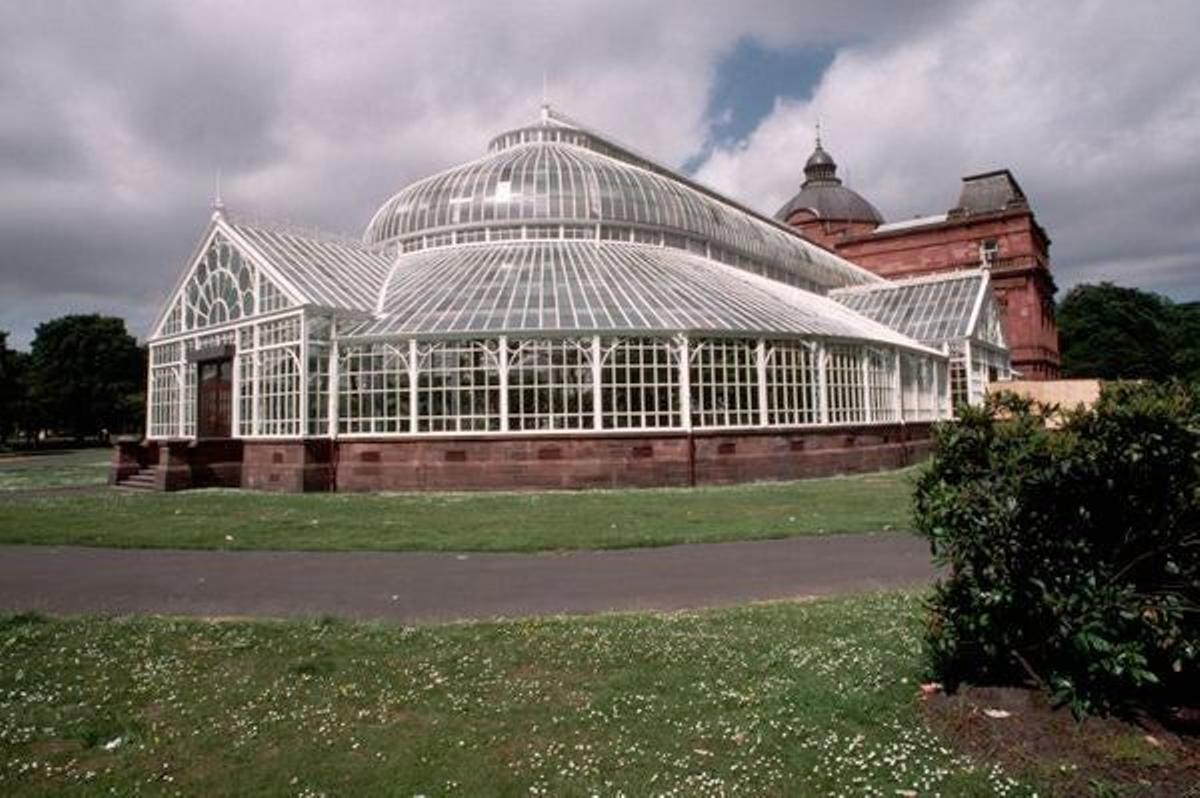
0;314;146;446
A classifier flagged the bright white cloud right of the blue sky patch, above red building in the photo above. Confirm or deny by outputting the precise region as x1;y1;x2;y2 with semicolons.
698;1;1200;299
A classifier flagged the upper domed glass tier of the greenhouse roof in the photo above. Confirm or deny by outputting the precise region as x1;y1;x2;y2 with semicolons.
364;112;881;292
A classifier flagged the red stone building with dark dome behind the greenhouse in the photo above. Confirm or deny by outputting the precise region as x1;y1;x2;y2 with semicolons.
775;139;1058;379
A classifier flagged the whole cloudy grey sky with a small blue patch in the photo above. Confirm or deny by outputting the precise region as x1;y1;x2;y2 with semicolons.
0;0;1200;347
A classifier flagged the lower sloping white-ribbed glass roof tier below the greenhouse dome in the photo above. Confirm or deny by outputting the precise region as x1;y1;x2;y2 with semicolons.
343;235;924;349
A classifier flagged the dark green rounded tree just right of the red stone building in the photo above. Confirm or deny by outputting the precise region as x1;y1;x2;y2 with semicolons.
1058;282;1175;379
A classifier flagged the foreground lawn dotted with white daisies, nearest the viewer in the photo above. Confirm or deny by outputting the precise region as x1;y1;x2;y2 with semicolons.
0;593;1031;798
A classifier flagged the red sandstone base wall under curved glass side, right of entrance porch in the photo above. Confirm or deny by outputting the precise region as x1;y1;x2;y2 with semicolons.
335;424;930;491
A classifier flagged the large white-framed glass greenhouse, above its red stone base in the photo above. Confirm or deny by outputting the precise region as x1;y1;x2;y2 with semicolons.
146;109;1007;448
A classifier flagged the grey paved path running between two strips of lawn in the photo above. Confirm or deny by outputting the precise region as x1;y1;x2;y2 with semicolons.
0;534;934;622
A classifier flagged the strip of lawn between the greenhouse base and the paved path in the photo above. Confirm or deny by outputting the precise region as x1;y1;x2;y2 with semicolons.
0;468;917;551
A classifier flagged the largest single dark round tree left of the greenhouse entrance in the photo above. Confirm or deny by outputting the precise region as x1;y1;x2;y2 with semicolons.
30;314;145;438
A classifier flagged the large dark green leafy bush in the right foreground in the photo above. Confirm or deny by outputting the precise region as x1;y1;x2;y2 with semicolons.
914;383;1200;713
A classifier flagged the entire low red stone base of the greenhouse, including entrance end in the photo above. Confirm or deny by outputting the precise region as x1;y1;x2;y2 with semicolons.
114;424;931;493
